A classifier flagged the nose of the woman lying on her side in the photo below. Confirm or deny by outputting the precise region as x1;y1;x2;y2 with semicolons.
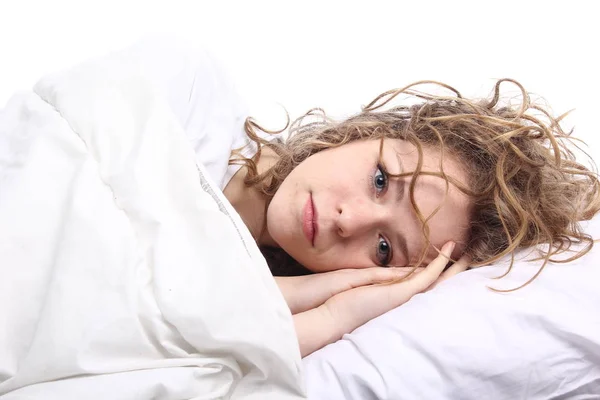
336;201;386;238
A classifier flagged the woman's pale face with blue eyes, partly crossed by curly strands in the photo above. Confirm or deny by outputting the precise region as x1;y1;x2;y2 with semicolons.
267;139;470;272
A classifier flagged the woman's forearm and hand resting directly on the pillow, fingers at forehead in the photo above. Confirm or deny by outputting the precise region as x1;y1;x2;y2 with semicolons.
294;243;469;357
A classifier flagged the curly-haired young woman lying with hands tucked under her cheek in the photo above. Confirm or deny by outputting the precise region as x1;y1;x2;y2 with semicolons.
224;80;600;355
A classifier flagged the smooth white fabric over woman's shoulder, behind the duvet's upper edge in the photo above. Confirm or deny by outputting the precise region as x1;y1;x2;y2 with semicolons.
90;36;256;189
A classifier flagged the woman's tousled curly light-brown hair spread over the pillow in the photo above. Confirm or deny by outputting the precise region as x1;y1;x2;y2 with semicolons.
230;79;600;290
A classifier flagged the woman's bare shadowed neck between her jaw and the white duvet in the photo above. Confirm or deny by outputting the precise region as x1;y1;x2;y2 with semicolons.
223;148;279;247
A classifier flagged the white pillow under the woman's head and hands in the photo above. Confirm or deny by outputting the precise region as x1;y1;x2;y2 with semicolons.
304;216;600;400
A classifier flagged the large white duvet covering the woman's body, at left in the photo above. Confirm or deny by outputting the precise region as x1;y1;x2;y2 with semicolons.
0;48;303;400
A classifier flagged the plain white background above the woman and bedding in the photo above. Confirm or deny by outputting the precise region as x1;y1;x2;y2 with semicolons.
0;0;600;159
